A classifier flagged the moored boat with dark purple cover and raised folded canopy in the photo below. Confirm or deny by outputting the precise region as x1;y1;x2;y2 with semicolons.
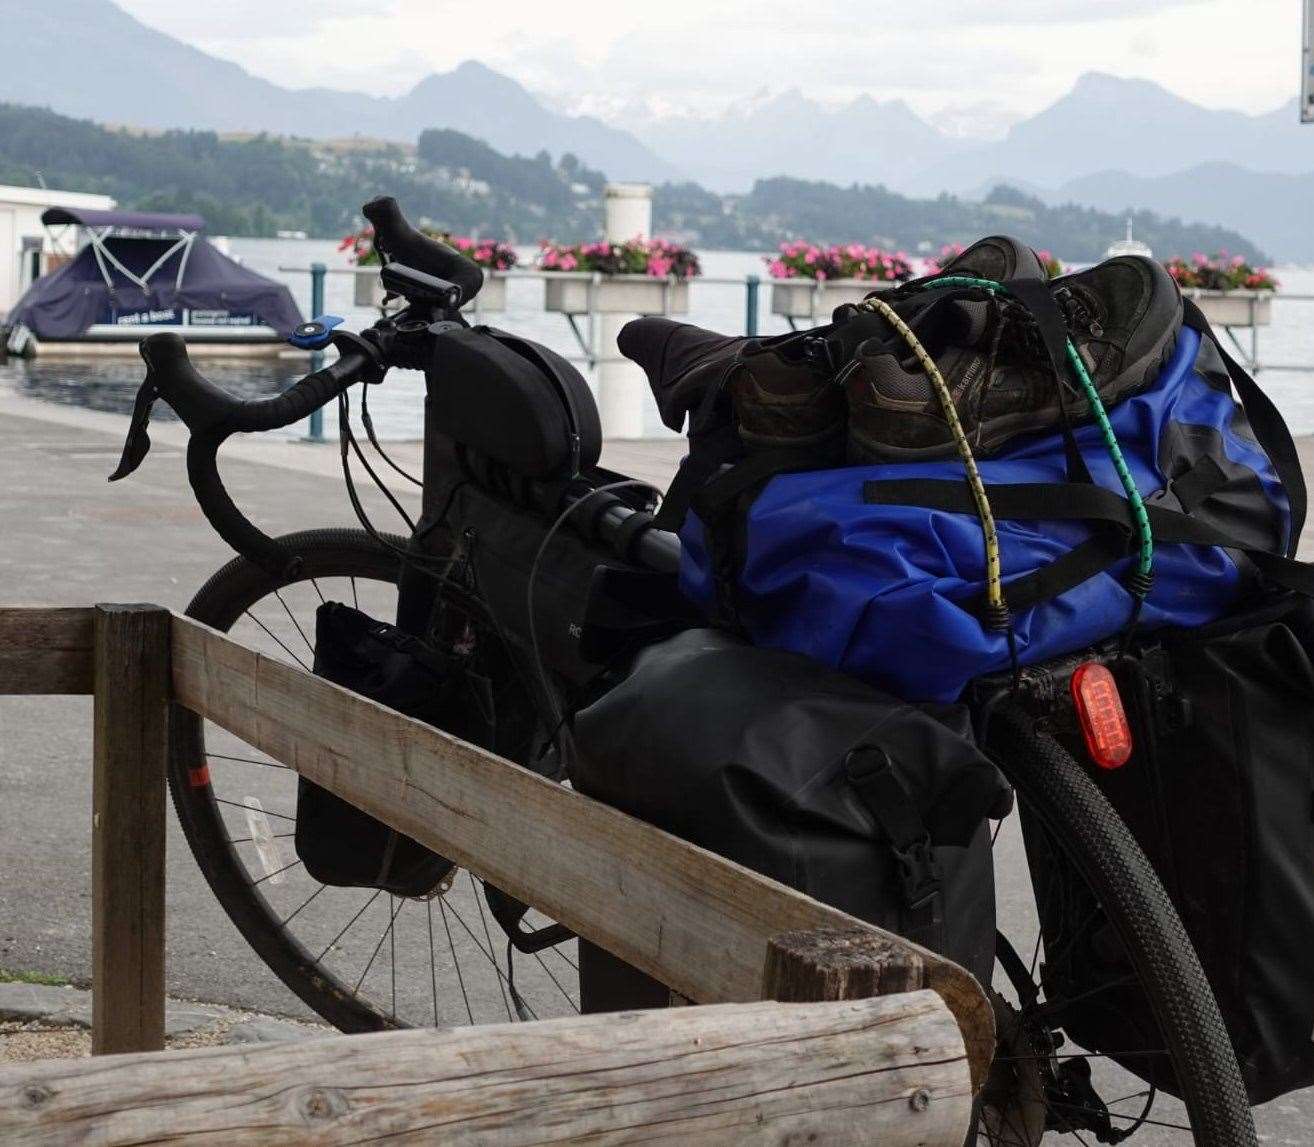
5;206;302;355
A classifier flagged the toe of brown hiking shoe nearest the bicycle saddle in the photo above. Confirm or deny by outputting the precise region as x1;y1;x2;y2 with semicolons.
729;331;846;465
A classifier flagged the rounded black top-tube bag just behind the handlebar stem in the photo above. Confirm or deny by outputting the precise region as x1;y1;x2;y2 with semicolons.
424;326;602;480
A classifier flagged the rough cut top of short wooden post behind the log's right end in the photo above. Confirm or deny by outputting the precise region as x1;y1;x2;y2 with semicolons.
762;928;926;1004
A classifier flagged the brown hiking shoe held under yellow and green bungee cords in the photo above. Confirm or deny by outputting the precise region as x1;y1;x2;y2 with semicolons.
841;252;1181;464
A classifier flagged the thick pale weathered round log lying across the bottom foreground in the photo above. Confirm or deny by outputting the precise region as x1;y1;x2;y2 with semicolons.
0;991;971;1147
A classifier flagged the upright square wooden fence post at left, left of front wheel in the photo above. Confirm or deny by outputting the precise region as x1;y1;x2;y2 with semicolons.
91;606;170;1055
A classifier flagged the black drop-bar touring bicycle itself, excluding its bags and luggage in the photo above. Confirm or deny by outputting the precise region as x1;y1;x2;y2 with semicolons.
116;200;1255;1144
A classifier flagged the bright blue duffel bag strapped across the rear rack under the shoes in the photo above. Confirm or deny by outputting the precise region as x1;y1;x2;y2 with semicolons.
681;301;1314;702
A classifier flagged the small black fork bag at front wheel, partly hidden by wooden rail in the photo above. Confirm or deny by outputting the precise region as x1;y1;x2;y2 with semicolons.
296;602;491;896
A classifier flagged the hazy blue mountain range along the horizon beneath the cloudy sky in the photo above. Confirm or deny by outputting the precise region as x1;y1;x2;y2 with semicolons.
0;0;1314;260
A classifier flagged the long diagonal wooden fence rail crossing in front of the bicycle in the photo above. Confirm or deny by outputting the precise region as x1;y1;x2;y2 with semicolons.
173;618;995;1085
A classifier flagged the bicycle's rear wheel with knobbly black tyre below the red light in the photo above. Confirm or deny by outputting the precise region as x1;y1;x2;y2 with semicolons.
978;704;1256;1147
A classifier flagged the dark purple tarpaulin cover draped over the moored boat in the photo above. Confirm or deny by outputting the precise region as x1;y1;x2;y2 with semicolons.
7;235;301;339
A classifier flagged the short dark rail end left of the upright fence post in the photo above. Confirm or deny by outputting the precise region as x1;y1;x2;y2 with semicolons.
0;606;93;696
